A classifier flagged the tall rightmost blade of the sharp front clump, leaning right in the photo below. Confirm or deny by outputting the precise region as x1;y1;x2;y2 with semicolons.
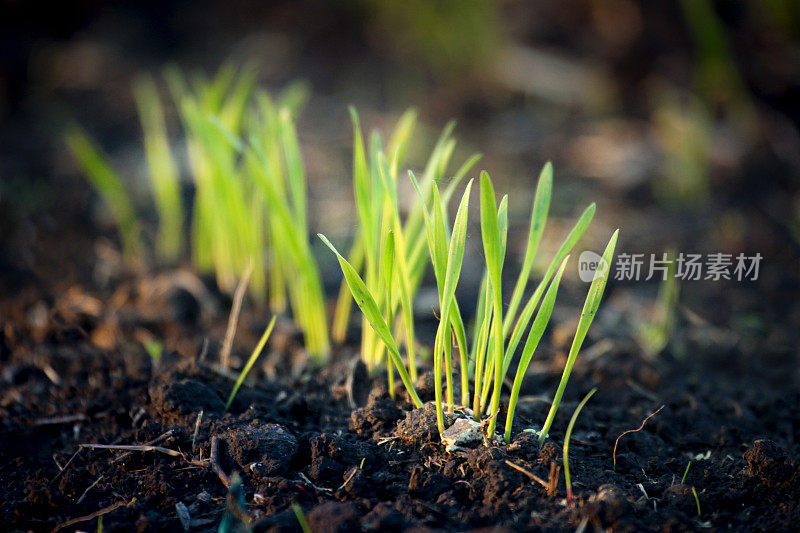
539;230;619;444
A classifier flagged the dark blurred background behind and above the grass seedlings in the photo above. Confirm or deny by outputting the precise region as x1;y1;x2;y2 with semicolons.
0;0;800;378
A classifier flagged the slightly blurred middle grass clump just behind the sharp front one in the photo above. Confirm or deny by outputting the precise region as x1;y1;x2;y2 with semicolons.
332;108;480;380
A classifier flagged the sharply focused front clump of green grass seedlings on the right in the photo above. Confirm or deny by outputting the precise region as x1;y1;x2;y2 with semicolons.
320;158;618;442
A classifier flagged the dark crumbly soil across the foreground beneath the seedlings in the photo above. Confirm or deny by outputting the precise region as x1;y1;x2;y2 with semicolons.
0;266;800;531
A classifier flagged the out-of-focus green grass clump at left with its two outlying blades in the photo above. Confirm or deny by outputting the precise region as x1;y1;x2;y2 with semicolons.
66;63;330;360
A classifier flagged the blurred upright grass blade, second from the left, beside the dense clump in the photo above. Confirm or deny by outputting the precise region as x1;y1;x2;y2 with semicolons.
134;77;183;262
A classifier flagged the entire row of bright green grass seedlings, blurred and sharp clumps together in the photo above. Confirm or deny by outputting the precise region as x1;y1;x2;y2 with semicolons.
67;62;617;442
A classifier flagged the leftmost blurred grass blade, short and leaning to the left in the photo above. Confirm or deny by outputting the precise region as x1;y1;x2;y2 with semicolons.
66;126;144;263
